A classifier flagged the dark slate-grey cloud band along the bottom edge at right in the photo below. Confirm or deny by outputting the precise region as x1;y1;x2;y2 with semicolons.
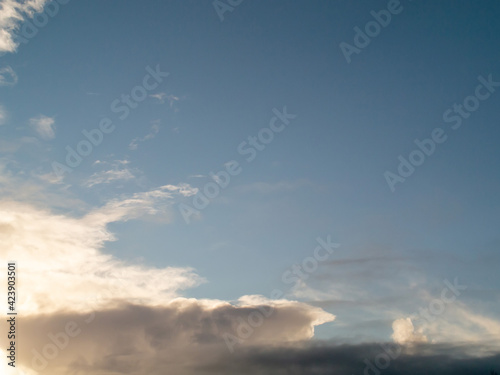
198;343;500;375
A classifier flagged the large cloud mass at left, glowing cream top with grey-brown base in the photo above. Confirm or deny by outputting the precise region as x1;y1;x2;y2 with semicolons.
0;180;334;375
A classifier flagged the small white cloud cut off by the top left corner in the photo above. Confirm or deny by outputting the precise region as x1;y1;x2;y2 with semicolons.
0;0;50;53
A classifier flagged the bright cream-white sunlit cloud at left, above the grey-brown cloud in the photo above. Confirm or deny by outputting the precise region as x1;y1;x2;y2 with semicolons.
0;197;203;316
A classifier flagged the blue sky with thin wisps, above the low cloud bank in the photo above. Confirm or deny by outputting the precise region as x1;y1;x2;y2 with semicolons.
0;0;500;374
